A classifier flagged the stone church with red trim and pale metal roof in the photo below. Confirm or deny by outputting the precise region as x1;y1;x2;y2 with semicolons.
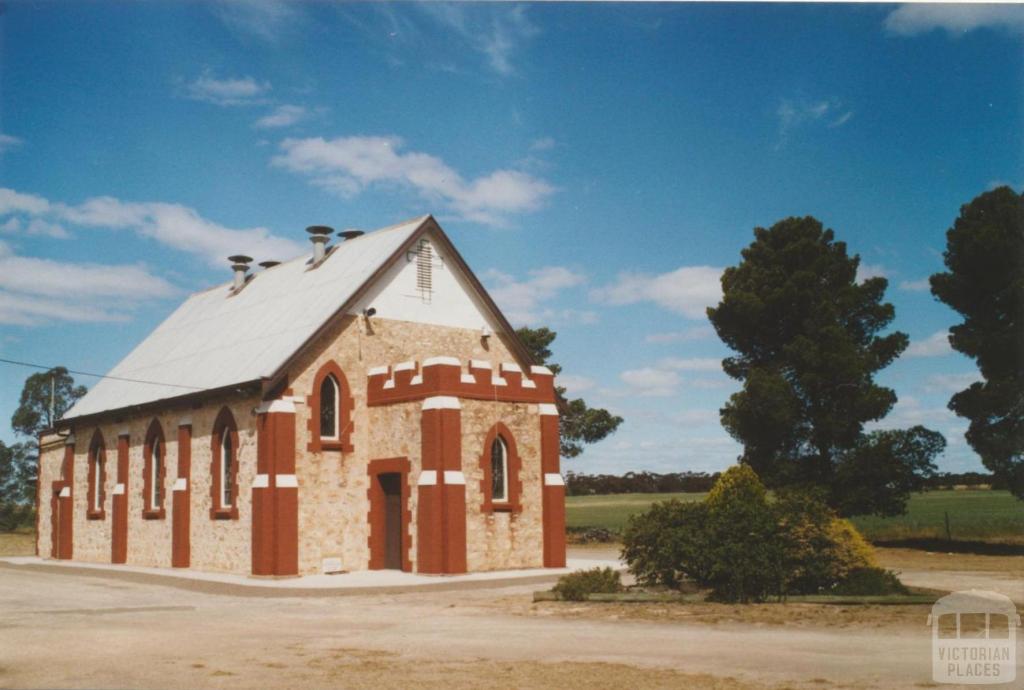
38;216;565;576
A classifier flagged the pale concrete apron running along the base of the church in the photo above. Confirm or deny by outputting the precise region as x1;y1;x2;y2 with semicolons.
0;556;624;596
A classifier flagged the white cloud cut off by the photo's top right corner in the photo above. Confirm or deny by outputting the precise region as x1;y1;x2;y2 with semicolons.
885;3;1024;36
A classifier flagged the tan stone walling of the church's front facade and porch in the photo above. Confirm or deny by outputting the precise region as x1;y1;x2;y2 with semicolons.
289;316;542;574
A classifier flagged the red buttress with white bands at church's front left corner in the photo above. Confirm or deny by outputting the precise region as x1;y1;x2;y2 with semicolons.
252;399;299;576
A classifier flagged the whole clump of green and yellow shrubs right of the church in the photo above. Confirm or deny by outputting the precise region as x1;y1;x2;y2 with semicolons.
623;465;877;602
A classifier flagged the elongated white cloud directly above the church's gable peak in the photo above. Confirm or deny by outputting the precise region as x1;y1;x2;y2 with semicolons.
271;136;555;224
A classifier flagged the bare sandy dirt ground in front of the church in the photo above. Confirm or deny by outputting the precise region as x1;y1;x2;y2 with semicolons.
0;552;1016;690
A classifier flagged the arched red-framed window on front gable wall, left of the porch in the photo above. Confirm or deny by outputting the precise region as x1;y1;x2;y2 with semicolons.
306;359;355;452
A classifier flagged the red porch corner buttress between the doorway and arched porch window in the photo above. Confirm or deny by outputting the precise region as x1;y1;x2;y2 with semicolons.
416;396;466;574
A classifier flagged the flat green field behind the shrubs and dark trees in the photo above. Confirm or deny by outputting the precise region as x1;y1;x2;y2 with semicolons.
565;490;1024;544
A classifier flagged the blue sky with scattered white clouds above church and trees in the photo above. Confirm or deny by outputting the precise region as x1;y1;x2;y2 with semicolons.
0;2;1024;472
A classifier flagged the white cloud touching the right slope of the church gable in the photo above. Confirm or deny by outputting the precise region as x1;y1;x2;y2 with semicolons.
484;266;596;325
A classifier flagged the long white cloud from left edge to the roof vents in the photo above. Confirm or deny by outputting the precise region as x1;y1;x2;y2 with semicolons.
0;187;305;267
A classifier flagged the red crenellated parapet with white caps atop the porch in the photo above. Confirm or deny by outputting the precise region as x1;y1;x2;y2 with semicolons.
367;357;555;406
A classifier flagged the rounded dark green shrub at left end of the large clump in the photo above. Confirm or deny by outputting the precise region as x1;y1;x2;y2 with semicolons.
622;501;711;589
